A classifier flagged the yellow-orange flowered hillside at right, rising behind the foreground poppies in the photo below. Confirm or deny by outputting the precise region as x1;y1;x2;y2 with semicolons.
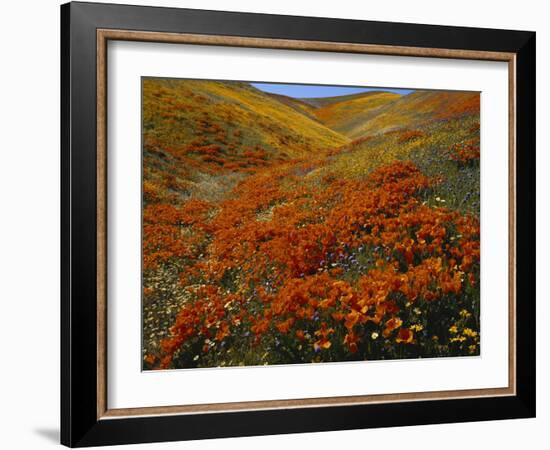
308;114;479;214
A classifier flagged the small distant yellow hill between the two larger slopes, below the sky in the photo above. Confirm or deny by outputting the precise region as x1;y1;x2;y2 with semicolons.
314;92;401;136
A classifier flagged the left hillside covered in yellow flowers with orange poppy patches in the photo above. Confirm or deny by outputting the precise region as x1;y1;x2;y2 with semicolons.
142;79;349;201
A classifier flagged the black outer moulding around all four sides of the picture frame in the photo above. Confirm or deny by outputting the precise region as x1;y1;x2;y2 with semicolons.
61;3;535;446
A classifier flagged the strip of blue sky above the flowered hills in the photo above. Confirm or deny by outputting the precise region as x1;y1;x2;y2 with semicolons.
250;83;412;98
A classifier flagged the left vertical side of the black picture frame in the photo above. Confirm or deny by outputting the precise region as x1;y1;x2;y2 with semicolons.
61;3;103;447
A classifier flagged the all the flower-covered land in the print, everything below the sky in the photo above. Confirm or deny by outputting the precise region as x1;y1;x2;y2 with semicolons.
142;78;480;370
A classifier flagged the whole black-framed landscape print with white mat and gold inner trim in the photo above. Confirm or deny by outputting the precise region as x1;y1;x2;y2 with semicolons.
61;3;535;447
